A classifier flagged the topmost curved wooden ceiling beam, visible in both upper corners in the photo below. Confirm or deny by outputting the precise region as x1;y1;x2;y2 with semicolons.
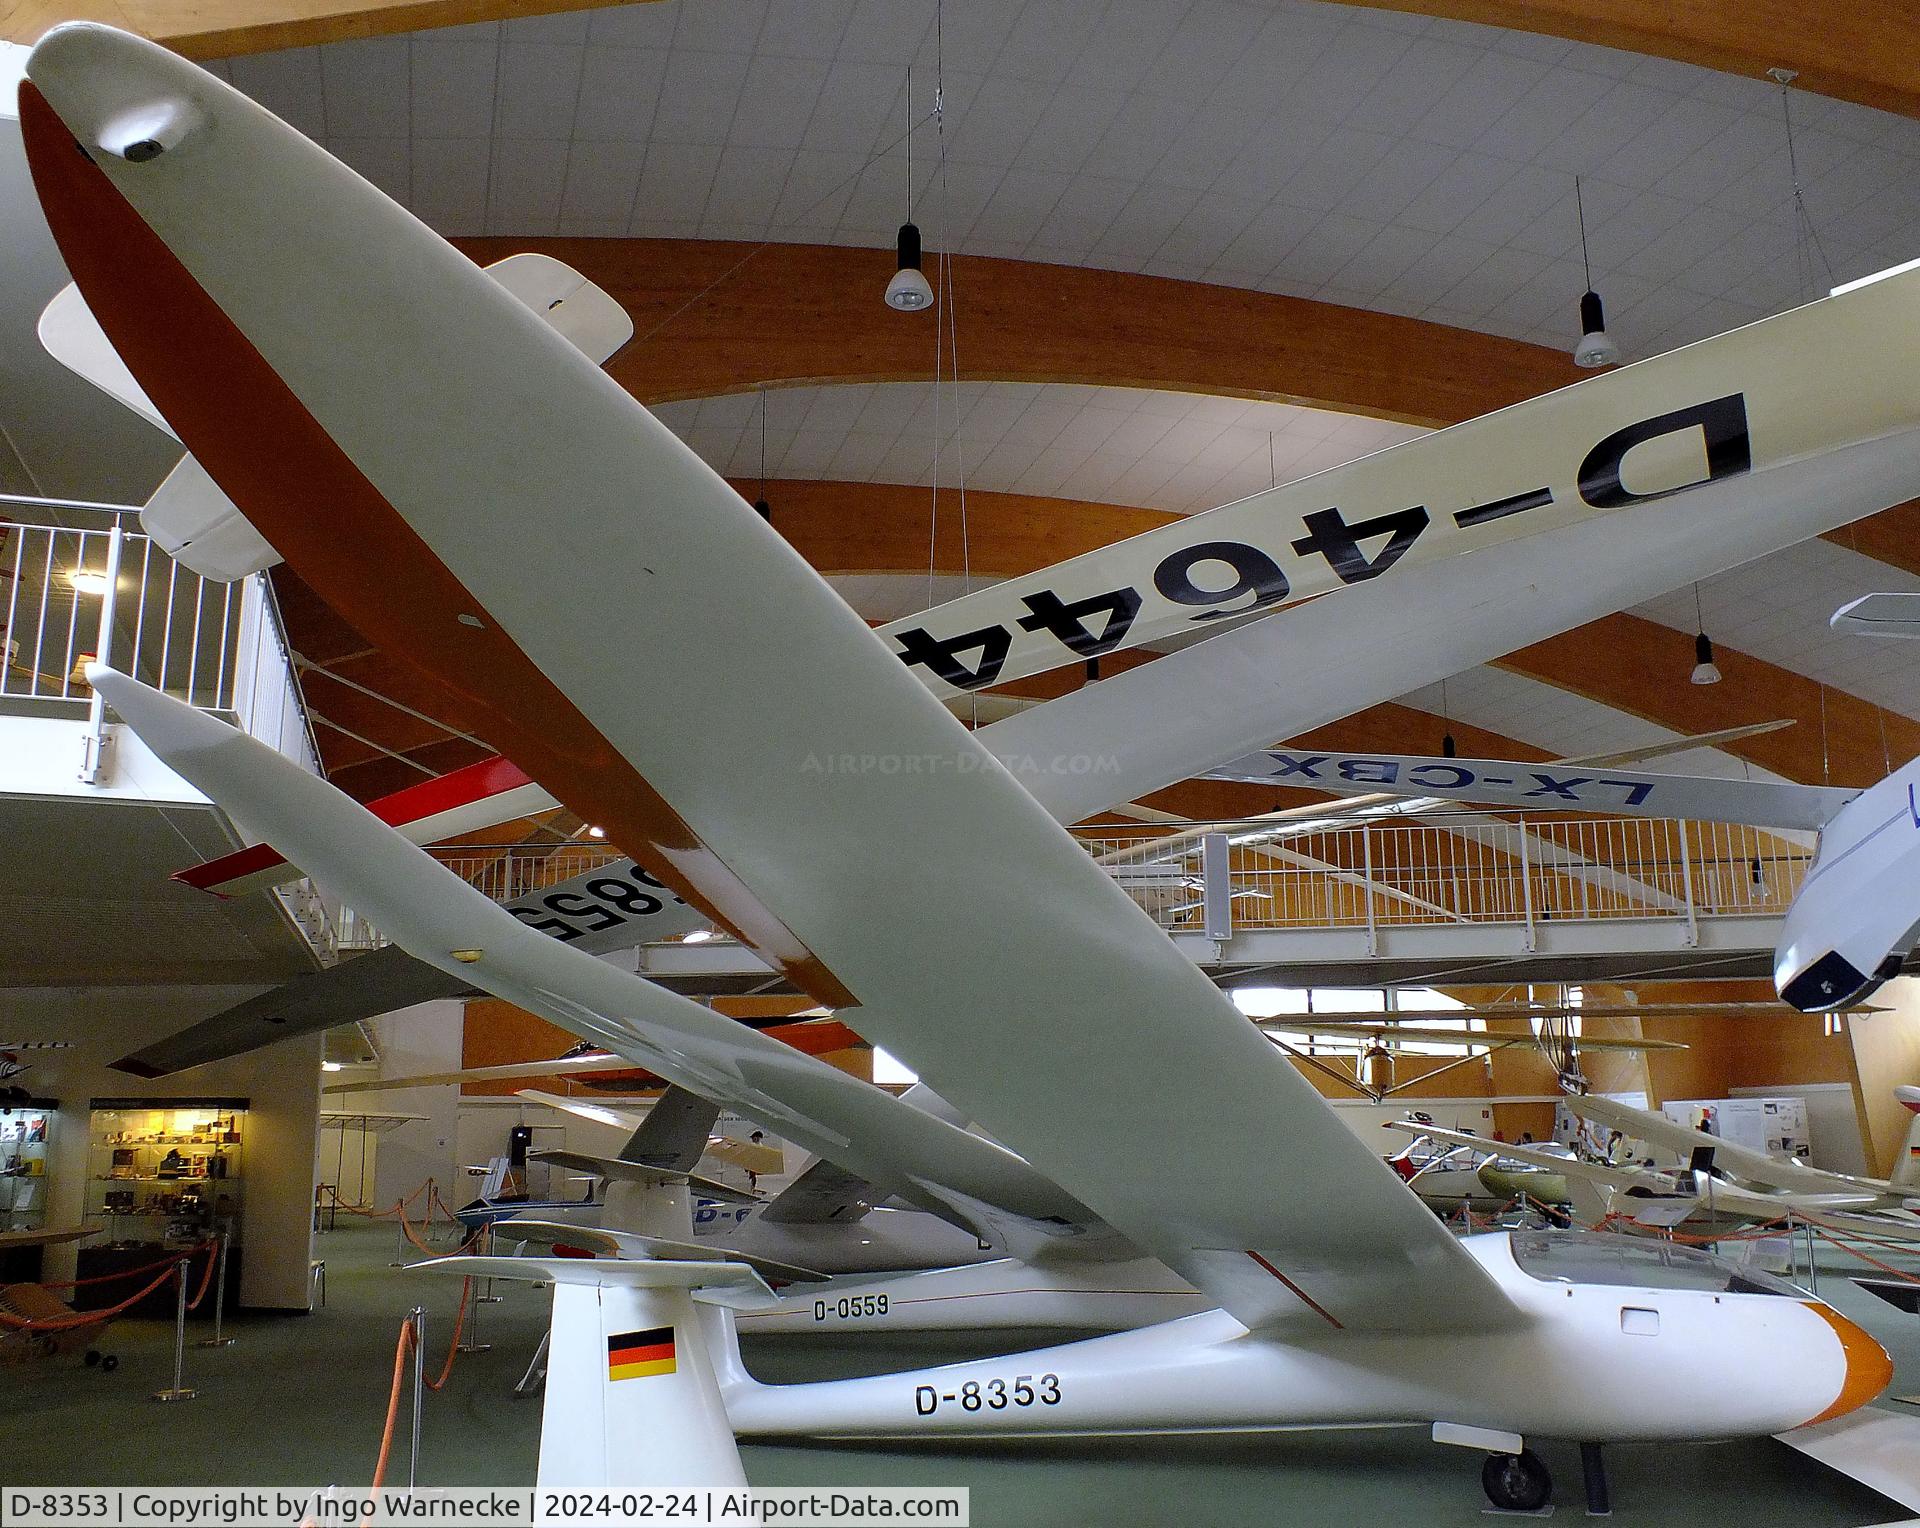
15;0;1920;117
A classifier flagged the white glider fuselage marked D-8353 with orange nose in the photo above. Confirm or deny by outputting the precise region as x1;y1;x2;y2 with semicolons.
707;1232;1889;1442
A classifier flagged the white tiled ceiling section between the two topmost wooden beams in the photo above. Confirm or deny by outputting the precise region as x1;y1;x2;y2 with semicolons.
198;0;1920;357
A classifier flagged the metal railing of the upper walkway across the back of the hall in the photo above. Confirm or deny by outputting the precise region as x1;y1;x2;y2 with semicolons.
340;812;1812;948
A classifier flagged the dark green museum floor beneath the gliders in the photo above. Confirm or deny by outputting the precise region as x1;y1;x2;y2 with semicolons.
0;1225;1920;1528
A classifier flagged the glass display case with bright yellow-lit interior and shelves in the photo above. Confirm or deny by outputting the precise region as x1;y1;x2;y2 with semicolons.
77;1098;248;1315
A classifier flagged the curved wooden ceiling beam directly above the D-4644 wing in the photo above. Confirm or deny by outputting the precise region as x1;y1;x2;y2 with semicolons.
453;238;1582;426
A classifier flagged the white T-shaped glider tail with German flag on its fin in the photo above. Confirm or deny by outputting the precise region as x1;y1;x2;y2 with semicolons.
417;1257;772;1490
